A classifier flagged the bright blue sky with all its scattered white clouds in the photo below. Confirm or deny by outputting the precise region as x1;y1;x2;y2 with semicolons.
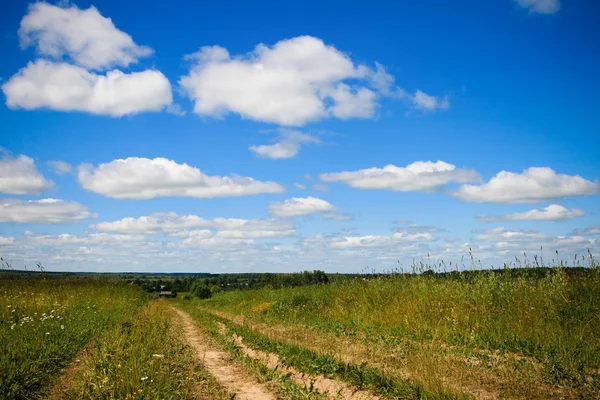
0;0;600;272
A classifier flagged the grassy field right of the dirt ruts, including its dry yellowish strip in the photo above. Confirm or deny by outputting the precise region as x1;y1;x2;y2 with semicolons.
197;268;600;398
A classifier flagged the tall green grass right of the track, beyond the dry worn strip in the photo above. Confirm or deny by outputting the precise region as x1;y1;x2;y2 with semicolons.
201;268;600;395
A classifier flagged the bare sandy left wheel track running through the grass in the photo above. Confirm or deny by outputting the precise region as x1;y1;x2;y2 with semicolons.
173;308;275;400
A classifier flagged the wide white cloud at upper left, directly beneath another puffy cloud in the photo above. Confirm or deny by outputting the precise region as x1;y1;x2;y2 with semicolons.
2;60;173;117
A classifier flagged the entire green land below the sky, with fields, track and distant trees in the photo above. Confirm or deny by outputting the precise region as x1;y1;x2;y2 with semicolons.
0;255;600;399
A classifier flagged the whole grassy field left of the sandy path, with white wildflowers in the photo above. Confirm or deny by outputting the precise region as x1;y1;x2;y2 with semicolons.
0;278;229;399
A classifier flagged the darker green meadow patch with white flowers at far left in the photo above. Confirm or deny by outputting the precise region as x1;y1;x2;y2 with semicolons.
0;279;146;399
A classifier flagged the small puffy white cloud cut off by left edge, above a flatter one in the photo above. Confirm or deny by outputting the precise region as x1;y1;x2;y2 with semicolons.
0;147;54;195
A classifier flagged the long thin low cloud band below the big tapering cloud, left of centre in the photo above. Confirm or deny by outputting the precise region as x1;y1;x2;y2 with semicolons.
92;213;296;239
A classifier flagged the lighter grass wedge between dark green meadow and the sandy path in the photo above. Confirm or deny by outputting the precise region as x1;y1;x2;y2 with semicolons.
61;300;229;399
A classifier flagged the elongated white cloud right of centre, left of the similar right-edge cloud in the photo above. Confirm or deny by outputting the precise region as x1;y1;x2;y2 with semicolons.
319;161;481;192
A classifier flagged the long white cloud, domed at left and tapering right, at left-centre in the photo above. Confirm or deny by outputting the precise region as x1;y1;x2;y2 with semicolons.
78;157;285;199
